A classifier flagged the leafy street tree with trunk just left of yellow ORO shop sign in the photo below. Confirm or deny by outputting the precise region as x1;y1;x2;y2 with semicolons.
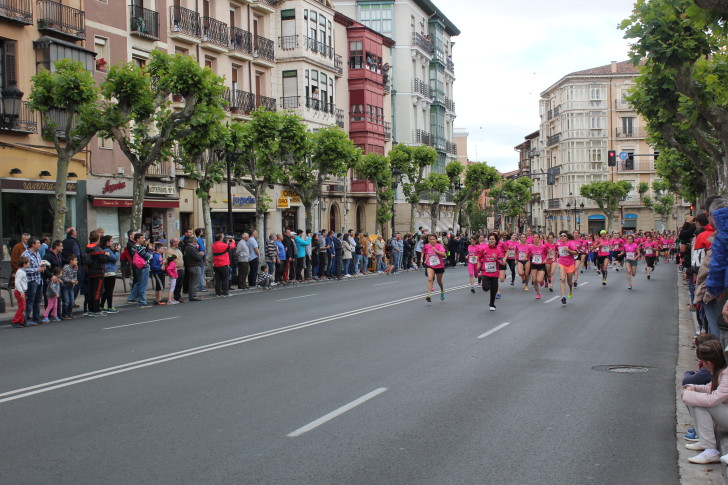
227;110;308;240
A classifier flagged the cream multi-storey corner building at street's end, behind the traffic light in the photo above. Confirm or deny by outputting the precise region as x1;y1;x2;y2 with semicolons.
532;62;689;232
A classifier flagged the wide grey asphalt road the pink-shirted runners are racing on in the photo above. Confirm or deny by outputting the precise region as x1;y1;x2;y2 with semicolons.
0;265;678;485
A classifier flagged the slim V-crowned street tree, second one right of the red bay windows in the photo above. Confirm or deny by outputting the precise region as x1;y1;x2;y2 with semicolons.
389;144;437;232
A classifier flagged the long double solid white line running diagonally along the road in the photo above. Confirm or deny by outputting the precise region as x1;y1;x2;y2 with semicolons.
0;285;468;404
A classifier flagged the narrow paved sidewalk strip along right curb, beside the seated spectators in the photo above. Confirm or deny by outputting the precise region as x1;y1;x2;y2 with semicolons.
675;273;726;485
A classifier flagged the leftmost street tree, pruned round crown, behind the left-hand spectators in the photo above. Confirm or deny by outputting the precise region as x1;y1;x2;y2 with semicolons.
30;59;101;240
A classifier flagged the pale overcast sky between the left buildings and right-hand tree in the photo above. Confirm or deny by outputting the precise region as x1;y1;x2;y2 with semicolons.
435;0;634;172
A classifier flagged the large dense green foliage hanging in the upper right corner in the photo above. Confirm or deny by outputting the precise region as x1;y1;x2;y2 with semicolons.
621;0;728;199
